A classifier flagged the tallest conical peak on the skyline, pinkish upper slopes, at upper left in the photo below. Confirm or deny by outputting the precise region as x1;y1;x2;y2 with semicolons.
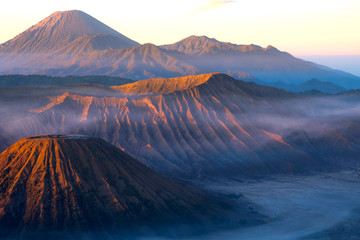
1;10;139;53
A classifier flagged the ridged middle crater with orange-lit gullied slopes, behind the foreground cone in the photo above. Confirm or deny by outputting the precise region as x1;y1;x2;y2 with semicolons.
1;73;324;177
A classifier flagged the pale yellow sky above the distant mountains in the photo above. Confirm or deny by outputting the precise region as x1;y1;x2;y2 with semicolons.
0;0;360;56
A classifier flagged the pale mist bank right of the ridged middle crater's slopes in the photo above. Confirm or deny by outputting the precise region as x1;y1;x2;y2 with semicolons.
238;96;360;137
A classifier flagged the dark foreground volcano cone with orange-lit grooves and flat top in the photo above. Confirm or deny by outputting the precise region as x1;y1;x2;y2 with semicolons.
0;135;236;236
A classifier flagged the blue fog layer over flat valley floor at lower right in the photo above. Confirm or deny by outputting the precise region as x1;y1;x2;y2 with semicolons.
143;172;360;240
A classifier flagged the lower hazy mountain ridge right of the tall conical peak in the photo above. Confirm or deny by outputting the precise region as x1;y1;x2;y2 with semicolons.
161;35;360;88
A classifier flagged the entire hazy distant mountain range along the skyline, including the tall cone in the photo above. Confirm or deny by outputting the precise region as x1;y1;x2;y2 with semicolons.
0;10;360;88
